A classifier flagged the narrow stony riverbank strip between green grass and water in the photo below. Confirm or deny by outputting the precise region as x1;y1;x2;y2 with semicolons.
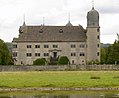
0;87;119;92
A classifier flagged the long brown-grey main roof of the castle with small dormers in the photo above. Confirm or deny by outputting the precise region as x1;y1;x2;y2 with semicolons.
13;26;86;42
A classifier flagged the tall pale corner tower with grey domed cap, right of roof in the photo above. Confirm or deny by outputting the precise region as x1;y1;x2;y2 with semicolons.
86;6;100;62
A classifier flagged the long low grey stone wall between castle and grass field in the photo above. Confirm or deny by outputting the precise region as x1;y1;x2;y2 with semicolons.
0;65;119;71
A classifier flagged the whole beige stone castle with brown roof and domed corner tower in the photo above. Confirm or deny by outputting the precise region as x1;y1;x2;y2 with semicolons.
12;7;100;65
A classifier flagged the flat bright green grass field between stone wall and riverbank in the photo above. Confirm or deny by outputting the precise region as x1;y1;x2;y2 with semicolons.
0;71;119;88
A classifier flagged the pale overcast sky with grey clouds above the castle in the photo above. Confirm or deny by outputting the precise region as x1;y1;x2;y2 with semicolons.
0;0;119;43
